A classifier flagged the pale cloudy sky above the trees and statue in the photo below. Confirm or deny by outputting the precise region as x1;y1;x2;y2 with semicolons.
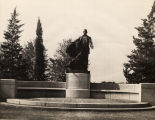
0;0;154;83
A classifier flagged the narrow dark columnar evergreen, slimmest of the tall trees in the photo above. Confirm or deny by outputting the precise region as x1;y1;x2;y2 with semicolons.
34;19;46;81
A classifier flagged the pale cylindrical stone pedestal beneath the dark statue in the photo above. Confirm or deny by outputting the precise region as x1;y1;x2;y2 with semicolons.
66;71;90;98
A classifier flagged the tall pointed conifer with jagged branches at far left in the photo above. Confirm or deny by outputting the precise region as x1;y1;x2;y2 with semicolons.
0;8;24;79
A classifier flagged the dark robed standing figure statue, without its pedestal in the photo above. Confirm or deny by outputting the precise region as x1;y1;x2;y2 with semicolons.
66;29;93;71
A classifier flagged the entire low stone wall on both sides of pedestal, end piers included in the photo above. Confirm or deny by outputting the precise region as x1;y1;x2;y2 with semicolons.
0;79;155;105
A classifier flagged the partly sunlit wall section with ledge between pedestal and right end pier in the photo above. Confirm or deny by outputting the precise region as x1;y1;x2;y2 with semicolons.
90;83;141;101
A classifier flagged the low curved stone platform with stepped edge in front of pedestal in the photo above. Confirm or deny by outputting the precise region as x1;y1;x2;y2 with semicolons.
7;98;151;110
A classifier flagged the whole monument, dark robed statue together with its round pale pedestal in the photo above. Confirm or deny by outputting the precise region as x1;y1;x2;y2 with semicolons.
66;29;93;98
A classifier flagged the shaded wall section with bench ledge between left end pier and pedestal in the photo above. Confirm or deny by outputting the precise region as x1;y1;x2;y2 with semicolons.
16;81;66;98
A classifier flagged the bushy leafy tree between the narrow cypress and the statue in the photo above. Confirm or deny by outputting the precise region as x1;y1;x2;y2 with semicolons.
48;39;71;82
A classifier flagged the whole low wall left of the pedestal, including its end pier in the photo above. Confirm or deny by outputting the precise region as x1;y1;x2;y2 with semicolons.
0;79;66;98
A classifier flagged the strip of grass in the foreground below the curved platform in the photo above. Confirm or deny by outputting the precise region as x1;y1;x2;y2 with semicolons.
0;104;155;120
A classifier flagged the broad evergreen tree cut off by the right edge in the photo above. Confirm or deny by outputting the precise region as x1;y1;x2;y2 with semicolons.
123;2;155;83
